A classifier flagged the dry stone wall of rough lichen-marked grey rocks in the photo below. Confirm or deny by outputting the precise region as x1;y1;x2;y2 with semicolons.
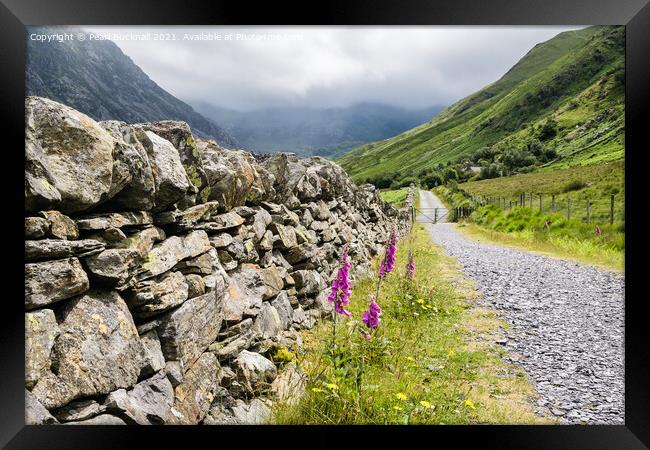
25;97;412;424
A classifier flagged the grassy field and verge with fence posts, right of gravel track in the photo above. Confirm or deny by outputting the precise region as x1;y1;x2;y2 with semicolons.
426;161;625;271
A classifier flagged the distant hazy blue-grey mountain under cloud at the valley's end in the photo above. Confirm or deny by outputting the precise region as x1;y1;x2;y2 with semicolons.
192;102;443;157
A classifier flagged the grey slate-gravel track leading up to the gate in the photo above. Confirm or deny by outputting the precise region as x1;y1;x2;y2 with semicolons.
420;191;625;424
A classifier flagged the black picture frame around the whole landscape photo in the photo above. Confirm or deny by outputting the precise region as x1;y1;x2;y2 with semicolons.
0;0;650;449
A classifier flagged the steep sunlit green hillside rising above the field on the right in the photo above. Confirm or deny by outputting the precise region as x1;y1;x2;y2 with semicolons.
338;26;625;184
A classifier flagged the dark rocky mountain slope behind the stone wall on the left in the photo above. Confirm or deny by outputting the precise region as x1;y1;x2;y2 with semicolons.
26;27;239;148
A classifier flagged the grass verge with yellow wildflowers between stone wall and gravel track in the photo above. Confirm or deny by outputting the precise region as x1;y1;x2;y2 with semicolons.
273;224;554;424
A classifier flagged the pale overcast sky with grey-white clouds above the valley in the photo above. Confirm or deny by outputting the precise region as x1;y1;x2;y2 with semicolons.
85;26;581;110
